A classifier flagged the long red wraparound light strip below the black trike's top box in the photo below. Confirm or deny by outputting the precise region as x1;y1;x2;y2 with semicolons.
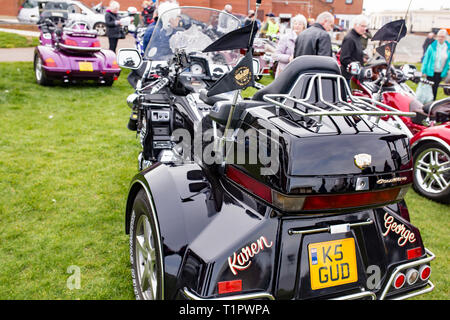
226;165;409;212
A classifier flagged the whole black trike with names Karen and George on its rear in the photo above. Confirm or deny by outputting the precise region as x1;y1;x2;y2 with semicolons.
118;7;434;300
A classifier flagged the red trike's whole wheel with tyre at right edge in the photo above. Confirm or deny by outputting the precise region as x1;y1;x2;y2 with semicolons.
413;142;450;204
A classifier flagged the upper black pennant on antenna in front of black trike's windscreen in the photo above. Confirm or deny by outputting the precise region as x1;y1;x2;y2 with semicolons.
203;23;258;52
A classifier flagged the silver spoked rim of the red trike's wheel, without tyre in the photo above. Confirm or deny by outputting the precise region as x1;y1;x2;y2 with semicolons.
414;148;450;194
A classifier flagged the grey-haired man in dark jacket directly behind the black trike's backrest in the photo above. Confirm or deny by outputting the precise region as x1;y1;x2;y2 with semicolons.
294;11;334;58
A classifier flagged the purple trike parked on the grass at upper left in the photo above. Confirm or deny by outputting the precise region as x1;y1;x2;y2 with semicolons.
34;11;121;86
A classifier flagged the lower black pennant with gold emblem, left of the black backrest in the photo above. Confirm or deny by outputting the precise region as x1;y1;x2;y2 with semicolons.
207;50;255;97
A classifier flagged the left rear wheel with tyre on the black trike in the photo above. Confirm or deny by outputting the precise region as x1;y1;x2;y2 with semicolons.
130;190;163;300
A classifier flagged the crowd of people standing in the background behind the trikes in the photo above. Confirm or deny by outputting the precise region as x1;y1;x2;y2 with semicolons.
105;0;450;98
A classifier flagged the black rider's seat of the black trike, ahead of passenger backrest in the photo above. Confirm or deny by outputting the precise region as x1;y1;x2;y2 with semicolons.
208;100;267;129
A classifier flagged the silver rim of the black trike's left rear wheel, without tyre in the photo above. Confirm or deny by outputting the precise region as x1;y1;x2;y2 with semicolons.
134;215;157;300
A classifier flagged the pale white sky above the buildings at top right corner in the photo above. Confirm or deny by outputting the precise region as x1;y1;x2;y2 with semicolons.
364;0;450;12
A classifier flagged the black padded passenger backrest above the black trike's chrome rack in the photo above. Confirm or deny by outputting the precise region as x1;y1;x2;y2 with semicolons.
253;56;341;101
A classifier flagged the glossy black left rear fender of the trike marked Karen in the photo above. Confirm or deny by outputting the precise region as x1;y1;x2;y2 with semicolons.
125;163;221;299
